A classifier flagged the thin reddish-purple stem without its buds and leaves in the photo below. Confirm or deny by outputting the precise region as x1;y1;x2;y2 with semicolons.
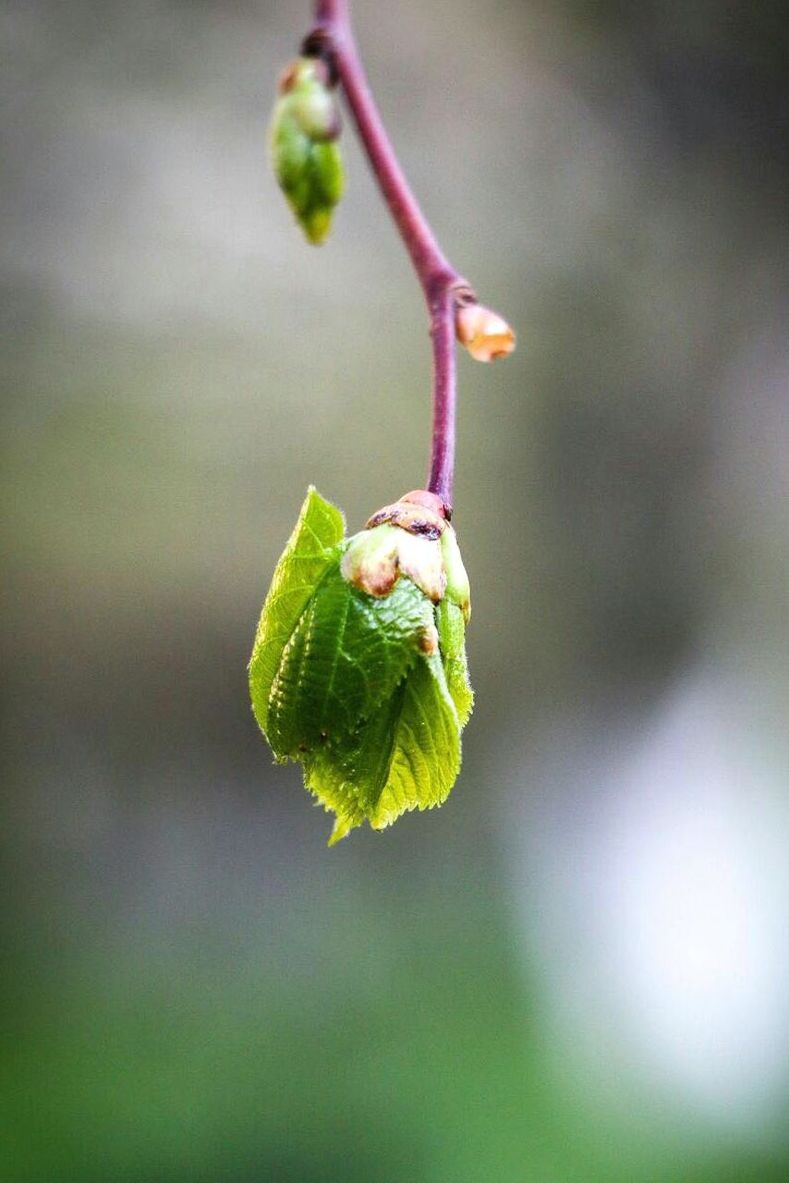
304;0;468;509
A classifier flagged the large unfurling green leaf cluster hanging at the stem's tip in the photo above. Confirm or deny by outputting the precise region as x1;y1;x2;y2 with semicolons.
250;489;473;842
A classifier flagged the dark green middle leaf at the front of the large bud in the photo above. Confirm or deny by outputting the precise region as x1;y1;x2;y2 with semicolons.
266;567;433;758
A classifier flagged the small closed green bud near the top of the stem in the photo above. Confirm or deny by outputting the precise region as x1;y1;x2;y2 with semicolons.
271;58;344;244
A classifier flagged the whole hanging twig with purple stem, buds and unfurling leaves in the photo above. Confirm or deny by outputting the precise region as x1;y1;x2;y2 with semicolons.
250;0;515;845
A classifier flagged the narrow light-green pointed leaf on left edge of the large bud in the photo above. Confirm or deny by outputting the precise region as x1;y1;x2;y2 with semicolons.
250;485;344;731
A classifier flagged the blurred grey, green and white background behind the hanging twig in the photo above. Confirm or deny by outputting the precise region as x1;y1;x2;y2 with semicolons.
0;0;789;1183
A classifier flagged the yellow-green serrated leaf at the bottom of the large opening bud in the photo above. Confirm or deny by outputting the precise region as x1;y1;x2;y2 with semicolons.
304;655;460;845
